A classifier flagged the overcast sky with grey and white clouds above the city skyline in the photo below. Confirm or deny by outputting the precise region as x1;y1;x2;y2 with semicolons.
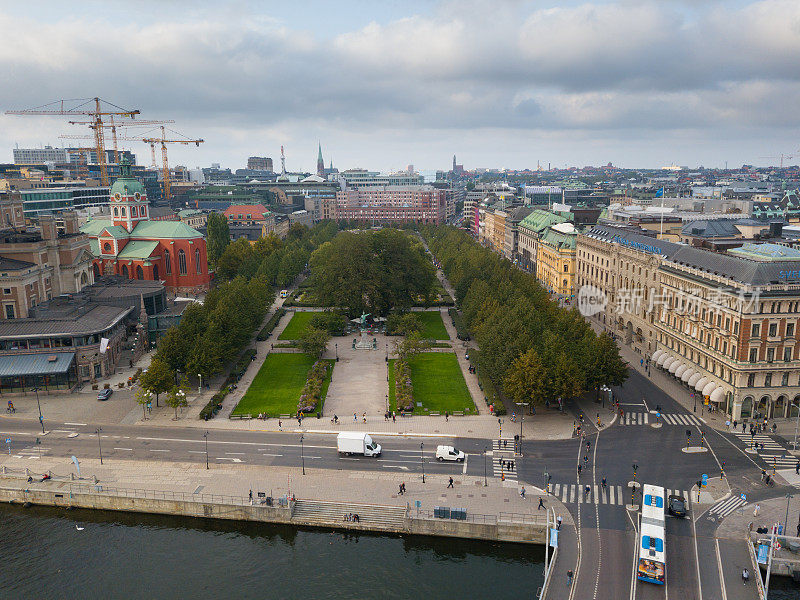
0;0;800;170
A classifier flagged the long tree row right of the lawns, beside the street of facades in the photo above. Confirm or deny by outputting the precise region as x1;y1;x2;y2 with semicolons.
422;227;628;404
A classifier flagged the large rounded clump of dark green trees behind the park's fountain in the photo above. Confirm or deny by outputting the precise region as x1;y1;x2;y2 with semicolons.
310;229;436;317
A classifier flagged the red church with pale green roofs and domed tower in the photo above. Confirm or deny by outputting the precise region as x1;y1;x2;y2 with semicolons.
81;158;210;294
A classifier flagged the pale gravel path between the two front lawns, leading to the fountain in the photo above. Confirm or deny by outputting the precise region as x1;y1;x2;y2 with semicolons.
323;334;396;421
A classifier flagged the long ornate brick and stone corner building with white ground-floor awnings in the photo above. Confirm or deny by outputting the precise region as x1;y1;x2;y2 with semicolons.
577;226;800;420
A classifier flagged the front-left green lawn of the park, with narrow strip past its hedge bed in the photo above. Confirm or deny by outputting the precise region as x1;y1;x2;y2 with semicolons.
232;353;335;417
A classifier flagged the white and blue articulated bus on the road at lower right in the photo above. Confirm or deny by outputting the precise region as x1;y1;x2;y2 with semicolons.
637;485;667;585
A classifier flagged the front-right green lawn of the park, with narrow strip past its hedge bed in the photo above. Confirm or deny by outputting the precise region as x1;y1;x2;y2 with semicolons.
389;352;476;415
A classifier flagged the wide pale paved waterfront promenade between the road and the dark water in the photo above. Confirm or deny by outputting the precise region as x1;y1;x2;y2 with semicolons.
0;456;572;525
